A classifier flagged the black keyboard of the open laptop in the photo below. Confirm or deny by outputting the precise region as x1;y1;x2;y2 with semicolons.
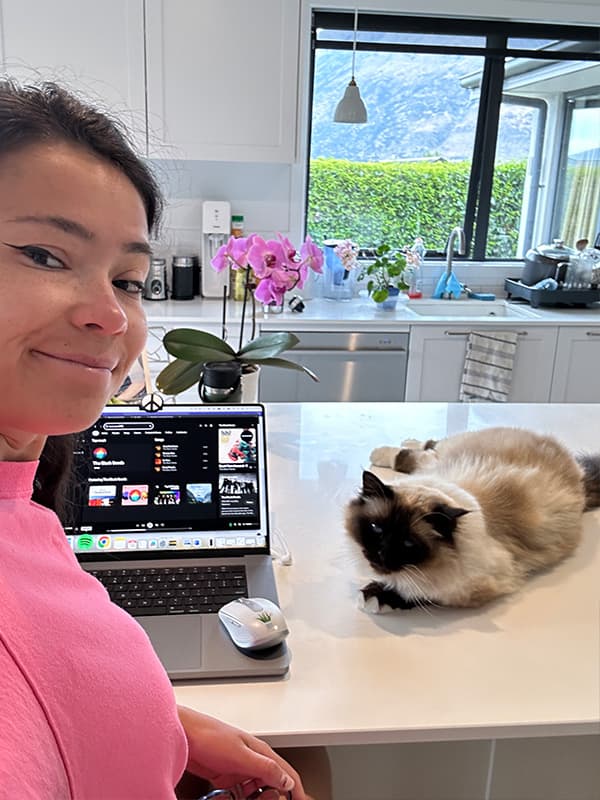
90;565;248;617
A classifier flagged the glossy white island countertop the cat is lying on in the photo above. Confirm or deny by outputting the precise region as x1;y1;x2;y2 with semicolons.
175;403;600;746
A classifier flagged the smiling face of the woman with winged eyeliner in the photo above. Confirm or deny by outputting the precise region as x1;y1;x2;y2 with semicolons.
0;144;150;435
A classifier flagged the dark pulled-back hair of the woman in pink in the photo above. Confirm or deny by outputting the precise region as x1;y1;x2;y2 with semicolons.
0;80;163;523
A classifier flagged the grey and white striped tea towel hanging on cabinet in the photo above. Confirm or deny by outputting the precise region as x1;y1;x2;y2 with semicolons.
459;331;518;403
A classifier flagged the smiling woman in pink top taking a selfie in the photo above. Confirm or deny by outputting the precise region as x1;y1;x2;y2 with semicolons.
0;82;324;800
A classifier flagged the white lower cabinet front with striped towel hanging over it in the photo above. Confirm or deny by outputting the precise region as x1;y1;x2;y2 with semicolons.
406;325;557;403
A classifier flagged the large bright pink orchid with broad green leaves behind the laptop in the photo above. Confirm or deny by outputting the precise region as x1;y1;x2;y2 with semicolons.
156;233;323;394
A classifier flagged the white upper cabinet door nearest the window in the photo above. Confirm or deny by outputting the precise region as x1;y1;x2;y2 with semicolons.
146;0;300;163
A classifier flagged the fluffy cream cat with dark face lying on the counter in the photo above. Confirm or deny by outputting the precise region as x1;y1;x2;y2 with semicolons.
345;428;600;613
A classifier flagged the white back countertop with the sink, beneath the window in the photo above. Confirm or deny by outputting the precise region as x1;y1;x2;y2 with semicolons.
144;296;600;333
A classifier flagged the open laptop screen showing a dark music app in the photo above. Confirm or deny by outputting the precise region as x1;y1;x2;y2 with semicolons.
65;404;269;561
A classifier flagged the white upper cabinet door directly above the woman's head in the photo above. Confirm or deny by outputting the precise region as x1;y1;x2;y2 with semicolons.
0;0;146;153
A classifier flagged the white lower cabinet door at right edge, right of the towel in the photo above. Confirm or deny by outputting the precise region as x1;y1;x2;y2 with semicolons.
550;326;600;403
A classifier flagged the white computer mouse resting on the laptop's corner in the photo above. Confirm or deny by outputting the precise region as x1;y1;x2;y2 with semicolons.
218;597;289;650
